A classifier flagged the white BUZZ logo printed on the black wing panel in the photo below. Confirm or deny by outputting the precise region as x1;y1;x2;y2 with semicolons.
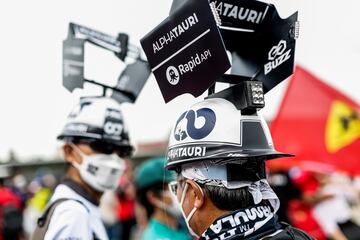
264;40;291;75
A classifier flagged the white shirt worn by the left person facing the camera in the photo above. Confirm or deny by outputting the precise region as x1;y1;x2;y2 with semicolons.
44;184;108;240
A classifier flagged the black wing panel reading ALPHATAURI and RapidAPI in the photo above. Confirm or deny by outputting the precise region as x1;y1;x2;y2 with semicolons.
141;0;230;102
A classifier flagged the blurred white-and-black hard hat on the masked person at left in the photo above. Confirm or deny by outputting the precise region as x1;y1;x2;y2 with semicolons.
57;97;133;156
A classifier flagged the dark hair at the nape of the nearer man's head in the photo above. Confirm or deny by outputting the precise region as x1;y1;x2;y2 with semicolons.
199;184;254;211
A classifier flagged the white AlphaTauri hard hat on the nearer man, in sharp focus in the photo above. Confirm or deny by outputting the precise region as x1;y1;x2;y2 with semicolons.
166;98;292;169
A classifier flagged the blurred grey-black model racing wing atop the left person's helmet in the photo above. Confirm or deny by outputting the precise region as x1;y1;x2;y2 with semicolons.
63;23;150;103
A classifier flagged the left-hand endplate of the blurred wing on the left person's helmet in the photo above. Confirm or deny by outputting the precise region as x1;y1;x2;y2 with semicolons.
63;38;85;92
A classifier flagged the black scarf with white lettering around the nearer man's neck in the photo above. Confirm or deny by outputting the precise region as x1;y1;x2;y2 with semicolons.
199;203;281;240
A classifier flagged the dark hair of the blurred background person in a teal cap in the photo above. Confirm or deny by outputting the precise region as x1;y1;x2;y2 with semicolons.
136;182;165;219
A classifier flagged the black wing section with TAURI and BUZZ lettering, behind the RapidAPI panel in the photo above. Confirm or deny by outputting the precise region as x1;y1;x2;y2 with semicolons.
170;0;299;92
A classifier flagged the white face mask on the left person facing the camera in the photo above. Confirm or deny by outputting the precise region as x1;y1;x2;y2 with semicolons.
72;144;125;192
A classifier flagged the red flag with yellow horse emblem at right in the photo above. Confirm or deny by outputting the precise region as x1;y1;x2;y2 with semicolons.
269;67;360;174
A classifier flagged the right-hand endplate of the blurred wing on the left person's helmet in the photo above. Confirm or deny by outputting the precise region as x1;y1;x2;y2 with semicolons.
111;59;151;103
